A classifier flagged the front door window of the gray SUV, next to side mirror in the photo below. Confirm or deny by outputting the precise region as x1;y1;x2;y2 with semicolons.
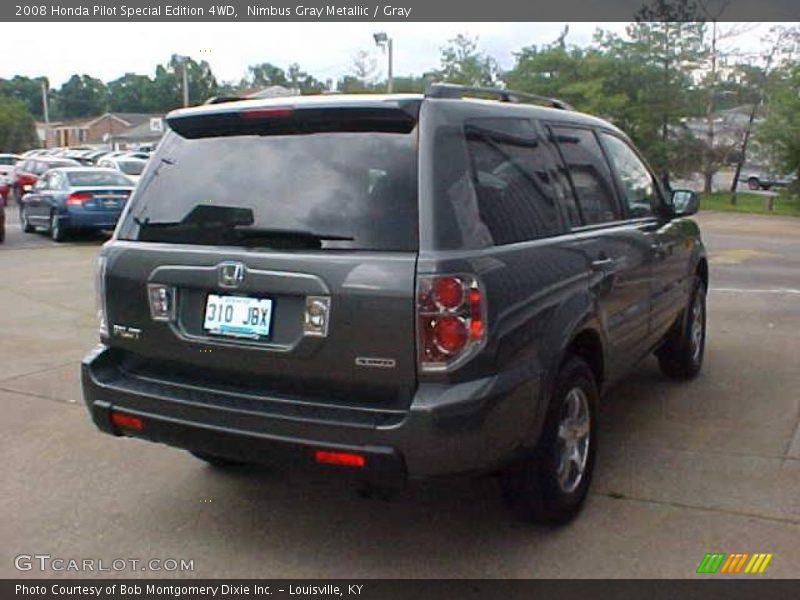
600;133;659;219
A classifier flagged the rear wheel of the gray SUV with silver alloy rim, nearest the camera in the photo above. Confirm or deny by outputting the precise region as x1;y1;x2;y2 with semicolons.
500;356;599;524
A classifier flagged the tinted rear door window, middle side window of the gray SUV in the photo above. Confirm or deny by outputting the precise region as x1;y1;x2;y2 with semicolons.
551;126;621;225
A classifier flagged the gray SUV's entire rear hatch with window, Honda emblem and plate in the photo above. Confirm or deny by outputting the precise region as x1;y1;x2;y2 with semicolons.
105;101;418;408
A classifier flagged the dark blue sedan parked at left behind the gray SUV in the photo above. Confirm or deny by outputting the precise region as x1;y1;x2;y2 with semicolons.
19;167;136;242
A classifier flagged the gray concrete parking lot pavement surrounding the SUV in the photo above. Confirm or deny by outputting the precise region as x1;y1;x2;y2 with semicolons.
0;208;800;578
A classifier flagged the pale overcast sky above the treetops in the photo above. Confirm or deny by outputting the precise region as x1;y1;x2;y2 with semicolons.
0;22;780;87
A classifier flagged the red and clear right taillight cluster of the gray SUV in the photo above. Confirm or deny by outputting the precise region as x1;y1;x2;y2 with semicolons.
417;275;486;372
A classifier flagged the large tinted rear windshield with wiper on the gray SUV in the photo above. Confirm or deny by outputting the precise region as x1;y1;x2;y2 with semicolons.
118;129;418;251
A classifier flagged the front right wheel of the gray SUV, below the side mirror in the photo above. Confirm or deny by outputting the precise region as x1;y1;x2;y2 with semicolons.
656;276;706;379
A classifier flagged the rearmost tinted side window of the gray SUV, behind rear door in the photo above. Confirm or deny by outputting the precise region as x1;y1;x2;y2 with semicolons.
464;118;561;246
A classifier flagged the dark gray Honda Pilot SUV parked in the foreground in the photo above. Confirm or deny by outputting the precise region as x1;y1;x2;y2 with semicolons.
82;84;708;522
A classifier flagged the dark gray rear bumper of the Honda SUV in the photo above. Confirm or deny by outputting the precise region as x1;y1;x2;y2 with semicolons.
81;346;543;484
